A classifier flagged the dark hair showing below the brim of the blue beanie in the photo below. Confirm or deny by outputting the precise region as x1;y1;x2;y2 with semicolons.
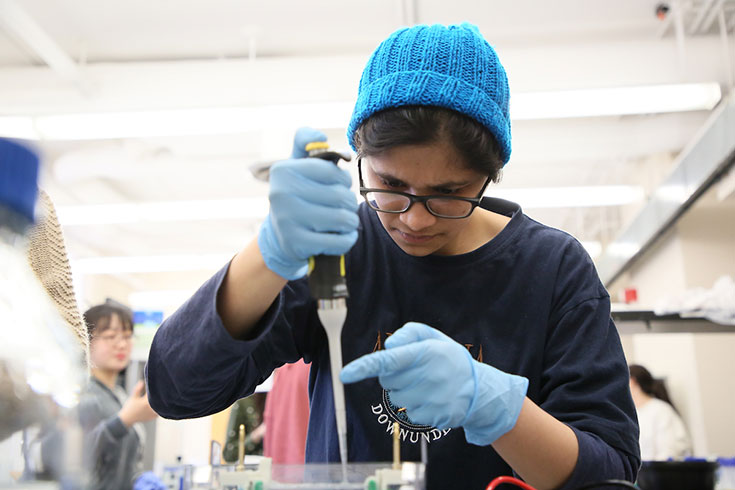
354;106;503;182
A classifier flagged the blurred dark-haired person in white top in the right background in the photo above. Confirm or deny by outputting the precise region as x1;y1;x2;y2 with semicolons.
629;364;692;461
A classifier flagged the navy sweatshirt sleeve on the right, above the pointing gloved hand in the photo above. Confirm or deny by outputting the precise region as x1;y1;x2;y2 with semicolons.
539;243;640;489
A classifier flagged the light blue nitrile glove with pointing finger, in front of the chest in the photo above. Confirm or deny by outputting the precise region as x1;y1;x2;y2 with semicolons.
340;322;528;446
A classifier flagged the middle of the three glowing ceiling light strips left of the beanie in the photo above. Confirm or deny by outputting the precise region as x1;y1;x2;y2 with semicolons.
56;197;268;226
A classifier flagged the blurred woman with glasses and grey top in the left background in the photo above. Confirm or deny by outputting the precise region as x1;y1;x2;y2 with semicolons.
78;302;157;490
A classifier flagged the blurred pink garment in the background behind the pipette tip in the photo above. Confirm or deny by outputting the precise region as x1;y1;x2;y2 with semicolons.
263;360;311;464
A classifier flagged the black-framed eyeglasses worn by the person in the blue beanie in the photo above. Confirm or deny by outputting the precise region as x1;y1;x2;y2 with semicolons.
357;159;490;219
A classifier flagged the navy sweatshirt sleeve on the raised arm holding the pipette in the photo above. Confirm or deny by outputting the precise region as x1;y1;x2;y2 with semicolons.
145;264;318;419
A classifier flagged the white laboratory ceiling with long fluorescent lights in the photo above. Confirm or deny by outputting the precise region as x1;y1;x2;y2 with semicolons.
0;0;735;309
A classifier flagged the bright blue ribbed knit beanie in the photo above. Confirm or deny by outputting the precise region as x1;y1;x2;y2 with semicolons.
347;22;510;163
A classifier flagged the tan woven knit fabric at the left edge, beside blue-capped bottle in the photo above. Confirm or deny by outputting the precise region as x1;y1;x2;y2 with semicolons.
28;189;89;367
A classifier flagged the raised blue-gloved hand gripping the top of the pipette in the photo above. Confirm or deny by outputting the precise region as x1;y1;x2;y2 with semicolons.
258;128;359;279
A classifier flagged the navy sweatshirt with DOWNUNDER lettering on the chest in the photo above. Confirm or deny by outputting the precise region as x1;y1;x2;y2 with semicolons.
146;198;640;489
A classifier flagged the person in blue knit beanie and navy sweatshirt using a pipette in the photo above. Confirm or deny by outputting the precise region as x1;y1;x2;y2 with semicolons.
146;23;640;490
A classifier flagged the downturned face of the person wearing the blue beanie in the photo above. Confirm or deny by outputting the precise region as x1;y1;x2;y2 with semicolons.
362;141;487;257
